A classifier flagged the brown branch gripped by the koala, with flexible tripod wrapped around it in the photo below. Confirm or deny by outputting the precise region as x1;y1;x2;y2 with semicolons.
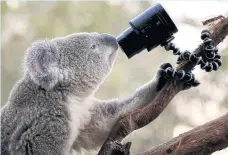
98;17;228;155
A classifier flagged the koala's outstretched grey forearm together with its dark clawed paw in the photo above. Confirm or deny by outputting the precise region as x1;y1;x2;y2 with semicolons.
94;63;200;118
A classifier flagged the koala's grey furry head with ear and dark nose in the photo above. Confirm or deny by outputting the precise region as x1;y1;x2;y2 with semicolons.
25;33;118;93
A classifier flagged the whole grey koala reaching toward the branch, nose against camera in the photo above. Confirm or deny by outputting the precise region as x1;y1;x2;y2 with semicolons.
1;33;198;155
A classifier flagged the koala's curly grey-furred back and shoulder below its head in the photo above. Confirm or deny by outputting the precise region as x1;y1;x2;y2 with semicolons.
1;81;69;155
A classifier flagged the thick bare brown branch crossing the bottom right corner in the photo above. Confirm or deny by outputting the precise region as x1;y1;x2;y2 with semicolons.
137;113;228;155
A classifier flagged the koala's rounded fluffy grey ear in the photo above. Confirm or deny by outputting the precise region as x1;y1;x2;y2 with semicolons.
25;40;61;89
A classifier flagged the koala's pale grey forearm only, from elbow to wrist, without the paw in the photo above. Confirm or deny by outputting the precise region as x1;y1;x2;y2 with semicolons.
91;72;163;118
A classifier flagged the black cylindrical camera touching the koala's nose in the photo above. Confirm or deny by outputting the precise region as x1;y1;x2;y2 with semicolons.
117;3;178;58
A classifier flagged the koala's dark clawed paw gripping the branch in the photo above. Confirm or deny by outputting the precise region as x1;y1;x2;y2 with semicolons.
157;63;200;90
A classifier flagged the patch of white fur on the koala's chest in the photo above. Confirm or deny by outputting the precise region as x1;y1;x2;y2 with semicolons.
66;97;92;151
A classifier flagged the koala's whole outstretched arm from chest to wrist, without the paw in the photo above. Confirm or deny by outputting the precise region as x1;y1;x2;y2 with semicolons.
78;76;160;150
